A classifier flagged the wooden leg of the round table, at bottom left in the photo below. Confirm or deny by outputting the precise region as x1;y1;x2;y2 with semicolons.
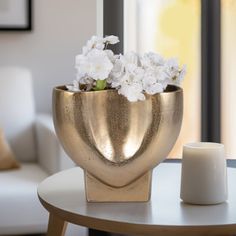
47;213;67;236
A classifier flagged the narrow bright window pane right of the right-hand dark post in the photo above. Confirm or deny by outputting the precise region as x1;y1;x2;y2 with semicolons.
221;0;236;158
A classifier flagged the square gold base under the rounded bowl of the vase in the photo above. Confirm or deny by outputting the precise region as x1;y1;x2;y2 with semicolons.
85;171;152;202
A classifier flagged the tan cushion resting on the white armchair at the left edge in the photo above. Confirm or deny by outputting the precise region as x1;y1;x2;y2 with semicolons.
0;129;20;170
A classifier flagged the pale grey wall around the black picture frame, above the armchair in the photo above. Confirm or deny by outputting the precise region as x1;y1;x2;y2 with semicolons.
0;0;96;112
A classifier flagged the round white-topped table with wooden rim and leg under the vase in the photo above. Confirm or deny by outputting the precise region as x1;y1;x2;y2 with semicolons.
38;163;236;236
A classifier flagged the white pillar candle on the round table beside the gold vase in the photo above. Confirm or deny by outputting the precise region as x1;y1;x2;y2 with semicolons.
180;142;228;204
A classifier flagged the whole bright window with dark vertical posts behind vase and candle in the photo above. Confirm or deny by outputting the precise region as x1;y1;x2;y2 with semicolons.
104;0;236;159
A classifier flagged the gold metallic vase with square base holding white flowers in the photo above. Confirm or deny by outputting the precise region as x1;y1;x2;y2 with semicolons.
53;86;183;202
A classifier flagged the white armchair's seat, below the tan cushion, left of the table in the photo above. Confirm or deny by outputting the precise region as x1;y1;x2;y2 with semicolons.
0;163;48;235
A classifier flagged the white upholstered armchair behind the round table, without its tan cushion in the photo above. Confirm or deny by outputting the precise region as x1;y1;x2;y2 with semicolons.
0;67;73;235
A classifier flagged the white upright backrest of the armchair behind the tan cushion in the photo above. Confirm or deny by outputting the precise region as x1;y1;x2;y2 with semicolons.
0;67;36;161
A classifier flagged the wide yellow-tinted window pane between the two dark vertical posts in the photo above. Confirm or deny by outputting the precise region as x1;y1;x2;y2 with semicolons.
124;0;201;158
